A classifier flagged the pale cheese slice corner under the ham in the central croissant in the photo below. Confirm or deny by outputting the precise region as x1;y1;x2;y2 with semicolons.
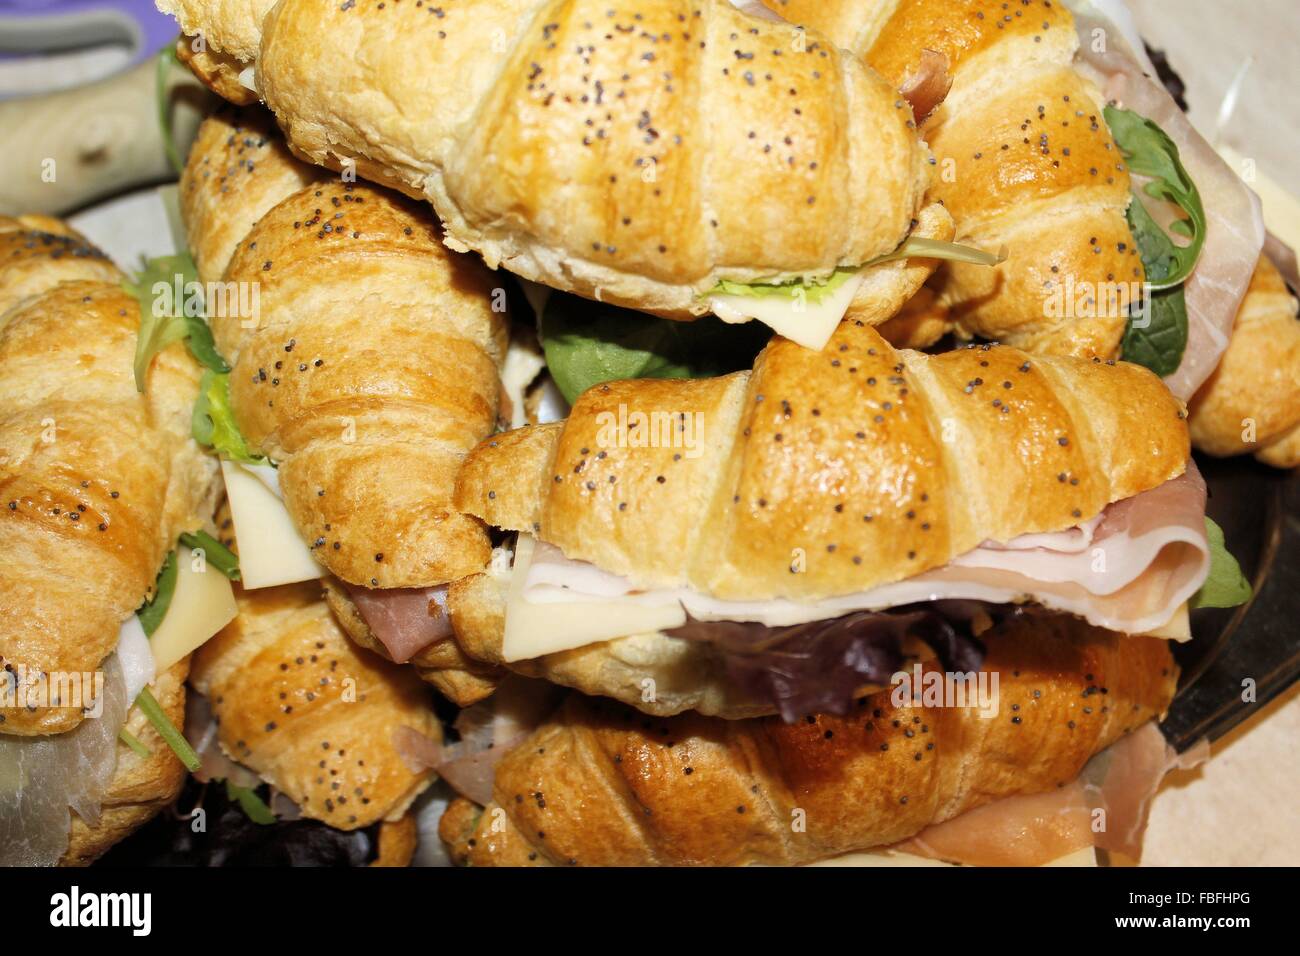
502;535;686;661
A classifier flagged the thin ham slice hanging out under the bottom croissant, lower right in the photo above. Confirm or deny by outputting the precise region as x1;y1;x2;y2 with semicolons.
894;723;1209;866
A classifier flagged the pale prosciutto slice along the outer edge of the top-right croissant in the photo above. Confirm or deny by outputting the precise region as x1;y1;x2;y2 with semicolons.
1067;0;1264;401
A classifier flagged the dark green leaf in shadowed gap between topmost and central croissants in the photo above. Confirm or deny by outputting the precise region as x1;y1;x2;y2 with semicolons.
541;293;772;402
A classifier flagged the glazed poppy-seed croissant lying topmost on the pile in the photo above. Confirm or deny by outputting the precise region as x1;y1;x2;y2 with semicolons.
159;0;928;316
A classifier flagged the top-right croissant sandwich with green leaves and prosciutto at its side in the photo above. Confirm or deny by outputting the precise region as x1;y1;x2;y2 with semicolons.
763;0;1264;401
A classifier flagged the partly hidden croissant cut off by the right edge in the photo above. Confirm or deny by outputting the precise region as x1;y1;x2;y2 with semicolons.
1188;256;1300;468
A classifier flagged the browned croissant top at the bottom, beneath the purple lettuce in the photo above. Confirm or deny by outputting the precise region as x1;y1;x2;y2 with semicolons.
439;615;1178;866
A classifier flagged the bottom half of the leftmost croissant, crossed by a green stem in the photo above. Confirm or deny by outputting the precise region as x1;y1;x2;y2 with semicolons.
60;657;190;866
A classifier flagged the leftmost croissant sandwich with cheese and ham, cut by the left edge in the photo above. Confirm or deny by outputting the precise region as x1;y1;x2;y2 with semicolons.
0;217;224;865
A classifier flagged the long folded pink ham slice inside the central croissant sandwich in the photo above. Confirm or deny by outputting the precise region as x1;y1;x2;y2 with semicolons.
524;460;1210;637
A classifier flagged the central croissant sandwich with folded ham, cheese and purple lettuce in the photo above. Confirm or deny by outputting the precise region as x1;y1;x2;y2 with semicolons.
450;323;1227;719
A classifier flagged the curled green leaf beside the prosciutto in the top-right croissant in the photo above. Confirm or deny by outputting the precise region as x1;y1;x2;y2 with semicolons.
1104;107;1206;290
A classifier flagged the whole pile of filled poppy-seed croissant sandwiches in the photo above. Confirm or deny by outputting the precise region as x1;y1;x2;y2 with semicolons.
0;0;1300;865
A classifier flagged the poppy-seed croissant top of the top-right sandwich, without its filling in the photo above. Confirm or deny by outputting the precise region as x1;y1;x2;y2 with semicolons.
763;0;1145;359
